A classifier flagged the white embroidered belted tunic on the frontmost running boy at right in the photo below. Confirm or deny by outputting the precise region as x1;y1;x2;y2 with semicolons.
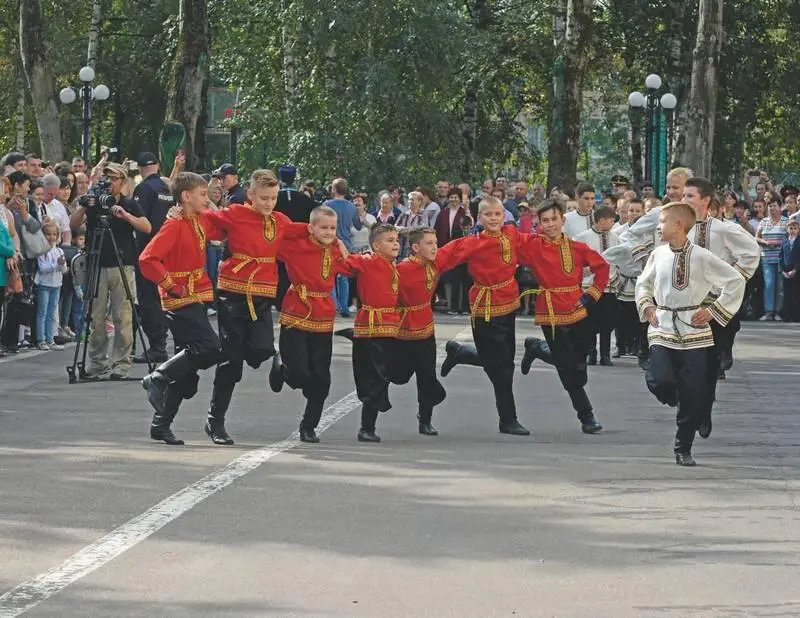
636;241;745;350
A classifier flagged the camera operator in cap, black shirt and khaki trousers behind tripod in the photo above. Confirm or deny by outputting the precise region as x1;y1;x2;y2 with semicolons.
70;163;152;380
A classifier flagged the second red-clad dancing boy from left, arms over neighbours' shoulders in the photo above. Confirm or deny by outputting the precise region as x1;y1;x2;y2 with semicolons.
199;170;306;444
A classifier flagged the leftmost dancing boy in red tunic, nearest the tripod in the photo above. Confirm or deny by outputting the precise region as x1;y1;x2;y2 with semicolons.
139;172;220;444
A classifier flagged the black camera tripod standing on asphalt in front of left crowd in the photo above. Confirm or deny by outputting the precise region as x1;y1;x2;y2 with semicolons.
67;215;155;384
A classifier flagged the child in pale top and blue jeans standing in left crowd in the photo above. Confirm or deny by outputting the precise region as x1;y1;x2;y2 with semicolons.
35;223;67;350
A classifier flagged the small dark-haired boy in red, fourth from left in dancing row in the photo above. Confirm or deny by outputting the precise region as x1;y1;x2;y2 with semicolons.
339;223;400;442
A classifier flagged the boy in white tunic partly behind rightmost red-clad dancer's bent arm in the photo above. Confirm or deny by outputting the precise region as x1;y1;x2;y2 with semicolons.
575;206;619;367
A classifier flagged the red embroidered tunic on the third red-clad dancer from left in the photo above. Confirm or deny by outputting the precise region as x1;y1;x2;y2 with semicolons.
278;229;346;333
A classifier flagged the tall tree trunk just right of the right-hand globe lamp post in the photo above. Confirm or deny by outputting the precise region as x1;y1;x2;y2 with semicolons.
683;0;723;178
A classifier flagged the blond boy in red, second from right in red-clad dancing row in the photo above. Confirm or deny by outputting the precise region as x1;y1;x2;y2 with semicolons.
442;197;530;436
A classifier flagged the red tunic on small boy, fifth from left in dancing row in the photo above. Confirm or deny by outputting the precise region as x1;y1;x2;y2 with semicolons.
397;242;466;339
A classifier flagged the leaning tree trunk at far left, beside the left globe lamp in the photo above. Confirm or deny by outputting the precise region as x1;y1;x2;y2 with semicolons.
19;0;64;161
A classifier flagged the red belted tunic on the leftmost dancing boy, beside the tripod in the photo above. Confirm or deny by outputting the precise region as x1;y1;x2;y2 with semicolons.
139;217;220;311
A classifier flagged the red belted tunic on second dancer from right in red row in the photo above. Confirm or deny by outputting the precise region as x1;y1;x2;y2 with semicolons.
448;225;530;322
